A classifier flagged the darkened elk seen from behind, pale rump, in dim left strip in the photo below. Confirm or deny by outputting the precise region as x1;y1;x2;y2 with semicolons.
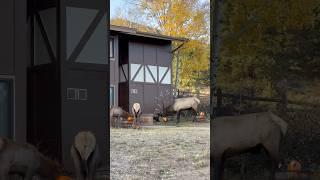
71;131;100;180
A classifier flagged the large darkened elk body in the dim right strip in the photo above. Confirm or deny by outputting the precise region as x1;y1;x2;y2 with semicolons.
212;112;288;180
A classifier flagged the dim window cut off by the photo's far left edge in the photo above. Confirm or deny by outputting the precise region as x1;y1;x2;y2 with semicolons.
0;79;13;138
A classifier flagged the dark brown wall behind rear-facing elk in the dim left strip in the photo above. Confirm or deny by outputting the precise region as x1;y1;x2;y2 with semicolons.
61;69;109;169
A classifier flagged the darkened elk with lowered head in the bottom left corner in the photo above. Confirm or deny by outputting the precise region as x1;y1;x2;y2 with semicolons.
0;138;63;180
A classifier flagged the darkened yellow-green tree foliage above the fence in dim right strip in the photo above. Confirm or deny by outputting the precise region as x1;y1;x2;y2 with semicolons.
218;0;319;95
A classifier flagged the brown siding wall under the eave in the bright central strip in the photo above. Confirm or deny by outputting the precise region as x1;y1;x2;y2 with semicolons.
129;40;173;114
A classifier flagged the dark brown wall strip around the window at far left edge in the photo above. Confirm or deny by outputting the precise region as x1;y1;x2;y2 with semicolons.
0;0;28;142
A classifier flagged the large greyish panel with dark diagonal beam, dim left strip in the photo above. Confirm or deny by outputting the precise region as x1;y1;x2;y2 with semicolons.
66;6;109;64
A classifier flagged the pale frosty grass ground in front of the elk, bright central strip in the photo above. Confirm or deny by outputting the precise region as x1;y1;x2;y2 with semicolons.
110;123;210;180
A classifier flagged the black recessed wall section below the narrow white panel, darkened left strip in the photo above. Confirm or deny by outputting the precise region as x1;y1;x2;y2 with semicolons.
27;64;61;158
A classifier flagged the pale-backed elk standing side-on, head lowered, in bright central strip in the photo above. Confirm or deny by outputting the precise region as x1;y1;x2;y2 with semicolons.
159;97;200;124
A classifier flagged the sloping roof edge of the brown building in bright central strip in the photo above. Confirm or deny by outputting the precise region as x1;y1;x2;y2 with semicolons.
110;25;189;42
